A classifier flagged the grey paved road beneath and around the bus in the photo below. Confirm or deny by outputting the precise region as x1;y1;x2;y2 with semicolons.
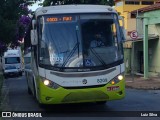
3;76;160;120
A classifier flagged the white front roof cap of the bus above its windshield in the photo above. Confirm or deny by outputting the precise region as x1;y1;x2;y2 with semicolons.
35;5;116;17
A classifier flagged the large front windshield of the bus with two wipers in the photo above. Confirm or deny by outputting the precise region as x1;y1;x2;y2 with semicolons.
38;14;123;71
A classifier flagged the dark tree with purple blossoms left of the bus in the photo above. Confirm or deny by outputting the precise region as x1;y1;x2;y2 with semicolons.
0;0;33;55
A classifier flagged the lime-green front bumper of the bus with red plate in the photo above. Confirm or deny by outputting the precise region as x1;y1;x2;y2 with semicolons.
37;80;125;104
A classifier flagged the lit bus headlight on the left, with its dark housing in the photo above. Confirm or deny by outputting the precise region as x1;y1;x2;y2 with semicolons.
43;79;60;89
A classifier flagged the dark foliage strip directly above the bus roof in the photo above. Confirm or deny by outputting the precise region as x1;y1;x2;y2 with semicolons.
43;0;114;6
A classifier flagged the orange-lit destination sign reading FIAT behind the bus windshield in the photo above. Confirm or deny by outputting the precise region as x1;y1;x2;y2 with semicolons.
46;16;75;22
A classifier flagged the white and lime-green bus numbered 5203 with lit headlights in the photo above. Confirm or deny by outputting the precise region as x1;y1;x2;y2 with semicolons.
27;5;125;104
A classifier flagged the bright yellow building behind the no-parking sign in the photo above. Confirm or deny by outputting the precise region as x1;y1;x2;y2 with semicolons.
115;0;156;38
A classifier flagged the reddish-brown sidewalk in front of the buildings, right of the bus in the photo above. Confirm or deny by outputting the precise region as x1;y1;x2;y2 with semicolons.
125;75;160;90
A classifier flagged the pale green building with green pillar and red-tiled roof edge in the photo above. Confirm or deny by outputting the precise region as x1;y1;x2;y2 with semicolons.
131;1;160;78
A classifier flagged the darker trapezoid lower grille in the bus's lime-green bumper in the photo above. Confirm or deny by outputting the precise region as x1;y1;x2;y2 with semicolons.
62;91;109;103
